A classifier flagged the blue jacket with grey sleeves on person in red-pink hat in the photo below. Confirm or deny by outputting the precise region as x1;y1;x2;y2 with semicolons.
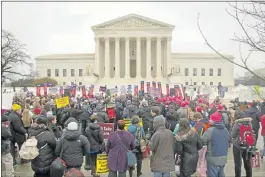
202;122;229;166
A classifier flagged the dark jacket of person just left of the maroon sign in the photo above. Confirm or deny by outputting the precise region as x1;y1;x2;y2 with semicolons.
85;123;104;152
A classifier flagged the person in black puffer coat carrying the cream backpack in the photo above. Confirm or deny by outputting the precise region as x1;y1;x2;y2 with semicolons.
29;117;56;177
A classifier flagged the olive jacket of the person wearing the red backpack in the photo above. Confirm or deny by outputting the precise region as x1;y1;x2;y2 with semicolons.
231;117;252;149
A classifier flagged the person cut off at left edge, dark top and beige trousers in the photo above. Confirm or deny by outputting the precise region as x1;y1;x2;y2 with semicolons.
1;124;14;177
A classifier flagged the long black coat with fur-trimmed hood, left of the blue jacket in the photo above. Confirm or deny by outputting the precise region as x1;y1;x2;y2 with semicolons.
175;130;202;176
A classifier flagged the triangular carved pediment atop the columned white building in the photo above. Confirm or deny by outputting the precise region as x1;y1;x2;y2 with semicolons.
92;14;174;30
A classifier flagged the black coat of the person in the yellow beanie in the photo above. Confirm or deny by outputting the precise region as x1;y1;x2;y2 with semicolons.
9;112;27;144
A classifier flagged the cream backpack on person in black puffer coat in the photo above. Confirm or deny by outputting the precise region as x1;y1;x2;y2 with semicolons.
19;132;47;160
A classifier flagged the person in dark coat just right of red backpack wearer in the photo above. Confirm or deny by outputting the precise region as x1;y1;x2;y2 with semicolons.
246;102;261;149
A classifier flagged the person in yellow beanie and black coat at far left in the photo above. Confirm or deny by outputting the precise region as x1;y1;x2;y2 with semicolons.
9;104;27;164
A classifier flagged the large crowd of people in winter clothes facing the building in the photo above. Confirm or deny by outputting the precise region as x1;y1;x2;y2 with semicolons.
1;94;265;177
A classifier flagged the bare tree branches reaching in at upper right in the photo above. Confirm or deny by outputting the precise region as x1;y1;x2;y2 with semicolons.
197;1;265;81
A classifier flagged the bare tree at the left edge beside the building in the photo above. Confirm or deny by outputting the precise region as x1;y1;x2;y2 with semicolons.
1;30;34;83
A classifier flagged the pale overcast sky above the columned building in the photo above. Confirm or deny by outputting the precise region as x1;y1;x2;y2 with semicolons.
2;2;265;76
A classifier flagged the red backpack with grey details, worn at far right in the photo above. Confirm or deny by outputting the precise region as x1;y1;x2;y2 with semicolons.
239;122;255;149
